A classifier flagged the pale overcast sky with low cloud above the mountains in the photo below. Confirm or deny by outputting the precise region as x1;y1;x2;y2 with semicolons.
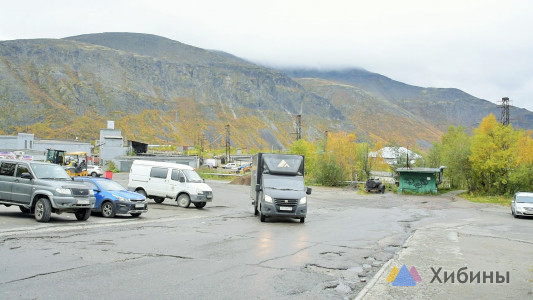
0;0;533;111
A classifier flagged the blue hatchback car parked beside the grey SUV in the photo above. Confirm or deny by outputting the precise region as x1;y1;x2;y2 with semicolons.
74;177;148;218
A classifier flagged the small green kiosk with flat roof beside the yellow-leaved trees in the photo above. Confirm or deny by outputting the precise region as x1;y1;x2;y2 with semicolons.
396;166;446;194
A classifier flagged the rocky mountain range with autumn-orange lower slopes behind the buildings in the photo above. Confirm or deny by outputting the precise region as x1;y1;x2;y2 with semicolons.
0;33;533;149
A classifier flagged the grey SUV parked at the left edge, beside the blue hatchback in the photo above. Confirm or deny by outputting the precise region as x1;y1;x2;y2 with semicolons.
0;159;95;222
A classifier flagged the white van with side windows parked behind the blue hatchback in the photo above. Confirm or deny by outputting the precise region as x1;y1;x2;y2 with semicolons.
128;160;213;208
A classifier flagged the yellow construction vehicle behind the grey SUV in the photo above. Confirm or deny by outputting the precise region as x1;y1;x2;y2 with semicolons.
45;149;89;177
